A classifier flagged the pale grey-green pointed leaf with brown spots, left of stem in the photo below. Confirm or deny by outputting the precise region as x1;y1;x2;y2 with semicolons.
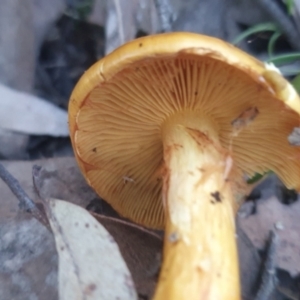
47;199;137;300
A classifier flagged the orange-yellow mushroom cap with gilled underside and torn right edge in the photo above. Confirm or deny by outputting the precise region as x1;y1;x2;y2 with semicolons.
69;32;300;228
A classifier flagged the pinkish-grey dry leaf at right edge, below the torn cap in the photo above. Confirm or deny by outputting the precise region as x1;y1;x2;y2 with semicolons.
238;196;300;276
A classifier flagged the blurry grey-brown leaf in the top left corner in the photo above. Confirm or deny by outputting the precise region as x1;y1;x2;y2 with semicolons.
0;0;34;91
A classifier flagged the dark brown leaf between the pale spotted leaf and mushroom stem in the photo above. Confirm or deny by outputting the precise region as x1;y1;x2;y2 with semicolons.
93;214;163;299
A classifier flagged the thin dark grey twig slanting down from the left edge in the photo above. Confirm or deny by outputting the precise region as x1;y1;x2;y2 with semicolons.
0;163;49;228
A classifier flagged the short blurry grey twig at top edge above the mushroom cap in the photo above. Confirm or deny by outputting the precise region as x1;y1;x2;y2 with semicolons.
154;0;175;32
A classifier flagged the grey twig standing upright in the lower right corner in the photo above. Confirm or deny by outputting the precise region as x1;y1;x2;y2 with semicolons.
255;231;278;300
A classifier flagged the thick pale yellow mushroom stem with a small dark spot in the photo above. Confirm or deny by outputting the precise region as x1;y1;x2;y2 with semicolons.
154;116;240;300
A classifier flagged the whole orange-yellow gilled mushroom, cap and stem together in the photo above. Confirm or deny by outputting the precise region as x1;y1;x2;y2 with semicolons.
69;32;300;300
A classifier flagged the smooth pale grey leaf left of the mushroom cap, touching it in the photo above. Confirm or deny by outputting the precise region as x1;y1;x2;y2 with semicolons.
0;84;69;137
